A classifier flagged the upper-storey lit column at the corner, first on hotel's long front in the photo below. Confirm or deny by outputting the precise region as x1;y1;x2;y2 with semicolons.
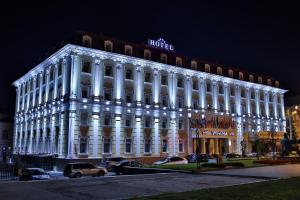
70;54;82;99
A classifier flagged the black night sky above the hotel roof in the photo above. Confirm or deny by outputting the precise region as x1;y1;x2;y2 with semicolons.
0;0;300;113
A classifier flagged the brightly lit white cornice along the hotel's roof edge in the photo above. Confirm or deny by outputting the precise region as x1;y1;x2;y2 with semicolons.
13;44;287;94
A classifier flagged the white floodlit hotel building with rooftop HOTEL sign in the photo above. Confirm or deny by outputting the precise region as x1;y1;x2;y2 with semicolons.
13;32;286;159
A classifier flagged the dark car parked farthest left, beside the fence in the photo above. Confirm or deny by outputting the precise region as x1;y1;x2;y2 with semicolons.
19;168;50;181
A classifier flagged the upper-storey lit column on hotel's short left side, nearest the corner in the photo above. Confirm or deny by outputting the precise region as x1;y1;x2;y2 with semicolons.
61;57;70;99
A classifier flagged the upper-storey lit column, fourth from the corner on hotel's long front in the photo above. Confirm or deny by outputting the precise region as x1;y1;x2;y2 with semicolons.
134;66;144;105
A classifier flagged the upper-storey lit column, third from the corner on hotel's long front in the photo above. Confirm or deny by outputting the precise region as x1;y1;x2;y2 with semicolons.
114;62;124;104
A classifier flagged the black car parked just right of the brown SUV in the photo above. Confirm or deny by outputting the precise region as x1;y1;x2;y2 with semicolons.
111;160;144;175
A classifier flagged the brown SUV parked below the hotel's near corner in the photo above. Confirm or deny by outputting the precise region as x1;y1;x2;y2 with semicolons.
64;162;107;178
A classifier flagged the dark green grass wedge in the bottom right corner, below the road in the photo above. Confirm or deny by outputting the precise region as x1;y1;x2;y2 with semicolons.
134;177;300;200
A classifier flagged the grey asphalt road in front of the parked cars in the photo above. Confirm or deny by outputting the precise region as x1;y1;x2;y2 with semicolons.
0;173;264;200
